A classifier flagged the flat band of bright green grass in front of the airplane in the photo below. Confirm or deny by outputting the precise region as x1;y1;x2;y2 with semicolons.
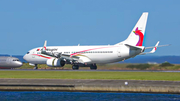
0;71;180;81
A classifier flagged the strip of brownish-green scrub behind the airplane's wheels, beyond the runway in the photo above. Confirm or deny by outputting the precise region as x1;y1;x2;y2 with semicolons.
16;62;180;70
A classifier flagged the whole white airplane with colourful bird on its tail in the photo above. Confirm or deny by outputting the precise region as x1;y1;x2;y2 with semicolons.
23;12;168;70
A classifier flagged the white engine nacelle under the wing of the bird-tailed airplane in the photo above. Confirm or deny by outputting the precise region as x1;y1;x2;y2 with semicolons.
46;58;65;67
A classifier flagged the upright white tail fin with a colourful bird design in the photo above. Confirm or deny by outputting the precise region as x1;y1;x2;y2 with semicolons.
117;12;148;46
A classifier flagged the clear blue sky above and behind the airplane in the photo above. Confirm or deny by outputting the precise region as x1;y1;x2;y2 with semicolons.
0;0;180;56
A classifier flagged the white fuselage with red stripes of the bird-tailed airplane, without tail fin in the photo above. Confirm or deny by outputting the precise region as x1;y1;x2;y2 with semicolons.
24;45;141;64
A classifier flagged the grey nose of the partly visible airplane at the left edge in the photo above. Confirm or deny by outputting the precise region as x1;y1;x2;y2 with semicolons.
0;56;22;69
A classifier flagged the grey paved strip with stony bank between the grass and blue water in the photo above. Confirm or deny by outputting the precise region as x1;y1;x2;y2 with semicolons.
0;79;180;94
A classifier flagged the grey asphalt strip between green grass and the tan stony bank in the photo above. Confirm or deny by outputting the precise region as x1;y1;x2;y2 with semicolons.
0;79;180;88
